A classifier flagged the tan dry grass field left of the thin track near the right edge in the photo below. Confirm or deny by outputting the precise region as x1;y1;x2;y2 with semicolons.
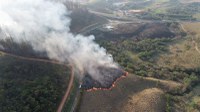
157;39;200;68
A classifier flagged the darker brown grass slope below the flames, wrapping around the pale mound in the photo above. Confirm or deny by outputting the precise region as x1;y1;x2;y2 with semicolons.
79;74;183;112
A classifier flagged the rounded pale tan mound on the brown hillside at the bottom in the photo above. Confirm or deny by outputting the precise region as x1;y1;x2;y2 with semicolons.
122;88;166;112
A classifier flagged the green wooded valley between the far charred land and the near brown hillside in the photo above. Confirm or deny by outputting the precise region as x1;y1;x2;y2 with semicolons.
99;38;200;87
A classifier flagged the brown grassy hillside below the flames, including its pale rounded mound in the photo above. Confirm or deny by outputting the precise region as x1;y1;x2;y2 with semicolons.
79;74;184;112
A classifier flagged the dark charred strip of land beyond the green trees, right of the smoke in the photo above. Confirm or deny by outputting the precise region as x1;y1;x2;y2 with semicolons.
87;22;185;40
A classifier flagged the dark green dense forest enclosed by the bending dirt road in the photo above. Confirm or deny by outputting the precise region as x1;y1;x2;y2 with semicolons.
0;56;71;112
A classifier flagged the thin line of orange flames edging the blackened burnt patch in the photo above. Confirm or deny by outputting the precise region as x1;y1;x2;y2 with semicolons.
86;72;128;92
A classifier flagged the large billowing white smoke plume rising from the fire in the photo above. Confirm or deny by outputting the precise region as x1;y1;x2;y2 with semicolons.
0;0;117;80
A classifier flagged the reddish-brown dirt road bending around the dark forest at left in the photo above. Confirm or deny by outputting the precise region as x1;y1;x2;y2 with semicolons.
0;51;74;112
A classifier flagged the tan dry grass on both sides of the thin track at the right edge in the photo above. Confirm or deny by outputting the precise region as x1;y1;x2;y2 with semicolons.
157;22;200;68
